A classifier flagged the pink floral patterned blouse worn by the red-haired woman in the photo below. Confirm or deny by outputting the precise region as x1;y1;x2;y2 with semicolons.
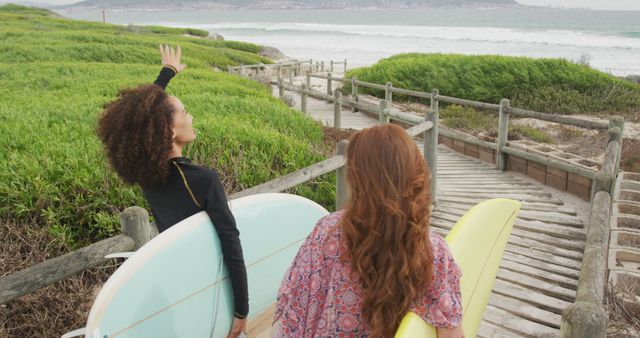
272;212;462;338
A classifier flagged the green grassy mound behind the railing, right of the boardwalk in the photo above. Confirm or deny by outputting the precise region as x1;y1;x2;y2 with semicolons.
347;53;640;118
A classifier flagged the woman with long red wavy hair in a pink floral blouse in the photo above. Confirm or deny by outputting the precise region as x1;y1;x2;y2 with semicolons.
272;124;464;338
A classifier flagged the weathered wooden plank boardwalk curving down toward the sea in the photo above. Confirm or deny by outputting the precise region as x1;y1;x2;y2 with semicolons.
250;80;585;338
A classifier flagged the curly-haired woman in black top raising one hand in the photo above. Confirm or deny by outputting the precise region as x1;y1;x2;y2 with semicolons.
97;46;249;338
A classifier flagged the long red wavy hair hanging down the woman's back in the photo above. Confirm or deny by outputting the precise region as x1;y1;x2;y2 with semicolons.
341;124;433;337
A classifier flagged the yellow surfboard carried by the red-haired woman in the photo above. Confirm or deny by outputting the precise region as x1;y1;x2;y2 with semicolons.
395;198;521;338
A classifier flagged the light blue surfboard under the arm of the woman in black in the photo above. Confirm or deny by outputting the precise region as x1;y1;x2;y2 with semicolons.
85;194;328;338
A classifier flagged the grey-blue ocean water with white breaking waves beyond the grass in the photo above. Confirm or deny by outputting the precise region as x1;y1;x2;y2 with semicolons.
60;8;640;76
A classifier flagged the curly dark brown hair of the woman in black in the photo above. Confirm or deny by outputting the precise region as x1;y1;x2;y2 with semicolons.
97;84;175;188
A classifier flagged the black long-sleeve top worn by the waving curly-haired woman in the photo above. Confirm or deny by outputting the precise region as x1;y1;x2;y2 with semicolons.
142;67;249;318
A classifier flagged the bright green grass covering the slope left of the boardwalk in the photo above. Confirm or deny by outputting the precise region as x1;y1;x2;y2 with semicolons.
0;6;334;247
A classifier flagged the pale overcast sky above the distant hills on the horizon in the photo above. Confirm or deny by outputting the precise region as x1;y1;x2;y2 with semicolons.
8;0;640;11
